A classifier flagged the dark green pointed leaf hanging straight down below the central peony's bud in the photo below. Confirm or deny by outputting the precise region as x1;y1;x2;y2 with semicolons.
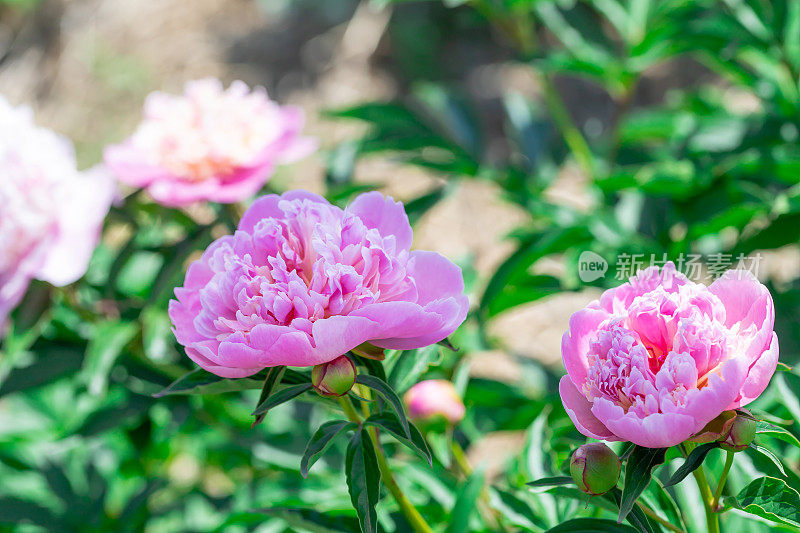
345;429;381;533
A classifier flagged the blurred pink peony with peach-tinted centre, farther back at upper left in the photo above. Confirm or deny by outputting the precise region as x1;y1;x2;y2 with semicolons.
104;79;316;207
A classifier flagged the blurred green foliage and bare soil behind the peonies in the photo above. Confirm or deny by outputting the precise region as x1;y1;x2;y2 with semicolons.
0;0;800;532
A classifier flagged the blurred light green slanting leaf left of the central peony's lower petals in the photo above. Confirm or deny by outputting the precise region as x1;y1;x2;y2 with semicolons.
82;321;139;395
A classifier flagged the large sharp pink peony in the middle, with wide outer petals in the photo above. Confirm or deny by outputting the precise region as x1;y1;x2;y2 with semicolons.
169;191;468;378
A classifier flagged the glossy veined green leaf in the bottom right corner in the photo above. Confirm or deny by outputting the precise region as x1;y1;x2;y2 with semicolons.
725;477;800;528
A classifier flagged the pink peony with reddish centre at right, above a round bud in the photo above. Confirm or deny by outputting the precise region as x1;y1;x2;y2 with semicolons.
559;263;778;448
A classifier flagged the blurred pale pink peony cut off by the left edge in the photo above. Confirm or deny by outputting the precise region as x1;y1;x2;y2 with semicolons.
0;96;115;326
